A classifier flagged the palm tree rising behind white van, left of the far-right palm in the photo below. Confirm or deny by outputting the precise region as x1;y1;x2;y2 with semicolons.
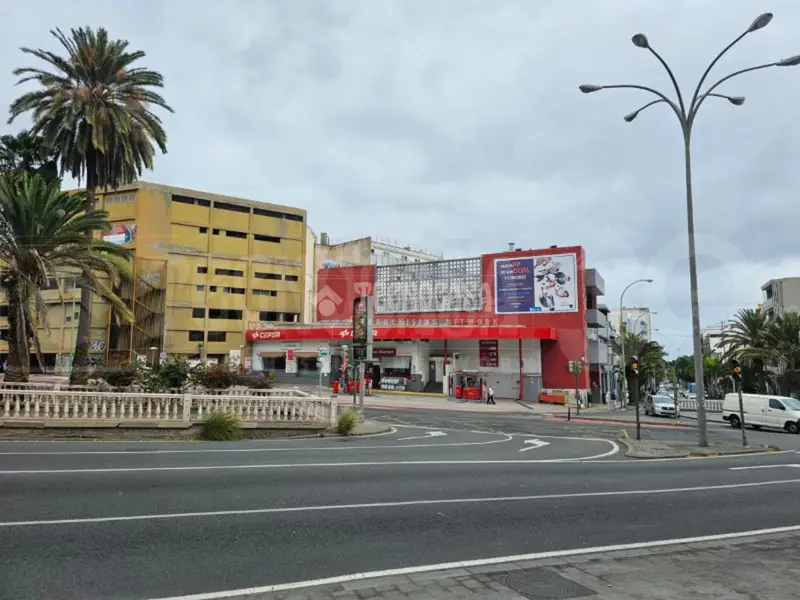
720;308;770;392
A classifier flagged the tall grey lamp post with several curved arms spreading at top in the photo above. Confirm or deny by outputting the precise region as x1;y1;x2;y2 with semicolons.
579;13;800;447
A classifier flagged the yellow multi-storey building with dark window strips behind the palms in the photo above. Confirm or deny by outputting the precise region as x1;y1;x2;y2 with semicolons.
0;181;314;372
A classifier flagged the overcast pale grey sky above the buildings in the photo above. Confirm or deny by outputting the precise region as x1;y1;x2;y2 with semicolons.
0;0;800;355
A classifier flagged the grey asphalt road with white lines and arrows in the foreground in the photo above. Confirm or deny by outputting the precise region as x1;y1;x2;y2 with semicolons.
0;411;800;600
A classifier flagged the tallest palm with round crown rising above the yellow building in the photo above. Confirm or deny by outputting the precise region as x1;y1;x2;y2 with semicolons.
9;27;172;383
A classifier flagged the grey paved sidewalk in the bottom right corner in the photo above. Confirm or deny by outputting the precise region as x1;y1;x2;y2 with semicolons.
252;532;800;600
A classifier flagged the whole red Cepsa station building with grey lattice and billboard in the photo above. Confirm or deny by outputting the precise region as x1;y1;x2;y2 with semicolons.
247;246;603;401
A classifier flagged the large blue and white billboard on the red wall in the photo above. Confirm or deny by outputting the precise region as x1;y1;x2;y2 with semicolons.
494;254;578;314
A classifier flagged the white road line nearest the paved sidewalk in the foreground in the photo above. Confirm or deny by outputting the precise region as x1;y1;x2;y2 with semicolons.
147;525;800;600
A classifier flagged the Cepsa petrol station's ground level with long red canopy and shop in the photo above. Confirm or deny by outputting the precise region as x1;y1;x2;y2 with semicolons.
247;326;555;399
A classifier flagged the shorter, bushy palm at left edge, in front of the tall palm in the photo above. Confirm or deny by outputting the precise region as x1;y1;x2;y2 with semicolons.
0;173;131;381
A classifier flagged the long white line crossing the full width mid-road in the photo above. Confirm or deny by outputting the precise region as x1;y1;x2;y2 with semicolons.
0;479;800;527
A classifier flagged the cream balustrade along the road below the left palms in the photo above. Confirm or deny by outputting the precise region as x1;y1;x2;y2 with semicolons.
0;388;336;427
